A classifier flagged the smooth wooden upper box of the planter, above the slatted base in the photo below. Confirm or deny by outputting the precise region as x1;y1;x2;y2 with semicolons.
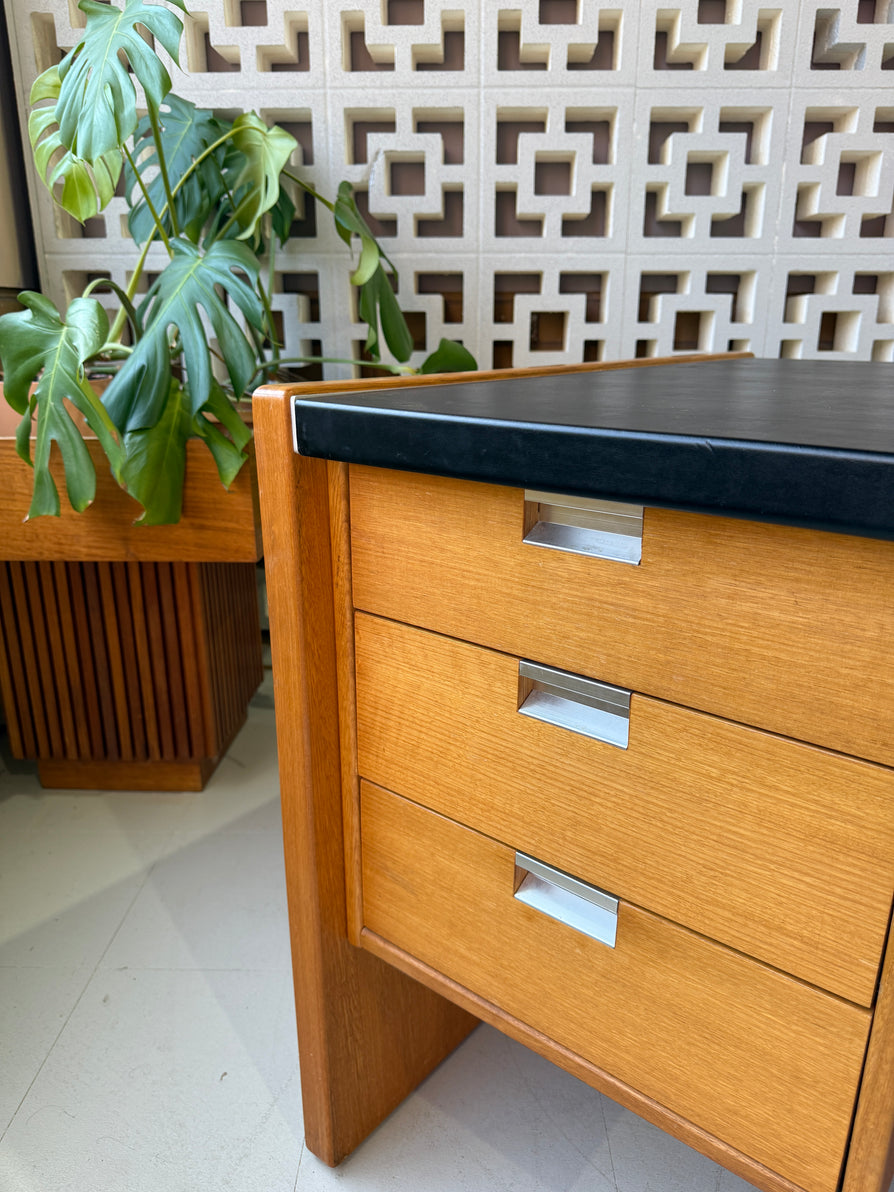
0;437;261;563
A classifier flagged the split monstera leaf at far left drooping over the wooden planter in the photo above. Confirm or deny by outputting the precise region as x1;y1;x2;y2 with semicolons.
0;292;123;517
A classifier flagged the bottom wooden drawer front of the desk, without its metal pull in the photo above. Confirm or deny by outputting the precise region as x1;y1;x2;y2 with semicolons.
361;783;870;1192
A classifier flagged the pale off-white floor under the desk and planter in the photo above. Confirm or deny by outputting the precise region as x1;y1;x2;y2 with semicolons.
0;685;750;1192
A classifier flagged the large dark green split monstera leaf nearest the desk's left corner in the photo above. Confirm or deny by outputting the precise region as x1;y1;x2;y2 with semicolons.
104;238;263;432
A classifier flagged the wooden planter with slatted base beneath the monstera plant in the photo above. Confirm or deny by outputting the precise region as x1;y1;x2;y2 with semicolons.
0;398;262;790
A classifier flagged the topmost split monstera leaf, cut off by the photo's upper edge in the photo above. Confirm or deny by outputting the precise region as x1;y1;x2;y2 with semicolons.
56;0;186;162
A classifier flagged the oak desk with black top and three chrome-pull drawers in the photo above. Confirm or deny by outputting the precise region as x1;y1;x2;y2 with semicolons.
255;359;894;1192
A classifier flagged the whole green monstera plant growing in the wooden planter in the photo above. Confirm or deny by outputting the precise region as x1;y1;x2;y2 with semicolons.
0;0;474;524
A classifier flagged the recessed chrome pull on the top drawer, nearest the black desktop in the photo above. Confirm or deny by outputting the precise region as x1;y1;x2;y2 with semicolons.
523;490;642;565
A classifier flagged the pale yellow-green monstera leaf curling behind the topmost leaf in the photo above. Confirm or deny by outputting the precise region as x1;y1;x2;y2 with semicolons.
27;67;122;223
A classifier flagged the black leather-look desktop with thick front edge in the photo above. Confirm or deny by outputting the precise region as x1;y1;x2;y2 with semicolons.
293;360;894;539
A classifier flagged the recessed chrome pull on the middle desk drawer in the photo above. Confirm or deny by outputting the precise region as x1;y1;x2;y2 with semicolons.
519;660;631;749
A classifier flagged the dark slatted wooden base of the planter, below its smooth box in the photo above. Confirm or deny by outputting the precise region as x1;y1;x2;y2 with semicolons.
0;563;262;789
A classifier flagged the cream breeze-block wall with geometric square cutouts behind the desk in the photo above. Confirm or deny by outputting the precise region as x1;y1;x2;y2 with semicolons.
4;0;894;378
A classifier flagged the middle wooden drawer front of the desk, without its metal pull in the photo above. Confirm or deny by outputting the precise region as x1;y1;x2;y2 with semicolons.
355;614;894;1005
